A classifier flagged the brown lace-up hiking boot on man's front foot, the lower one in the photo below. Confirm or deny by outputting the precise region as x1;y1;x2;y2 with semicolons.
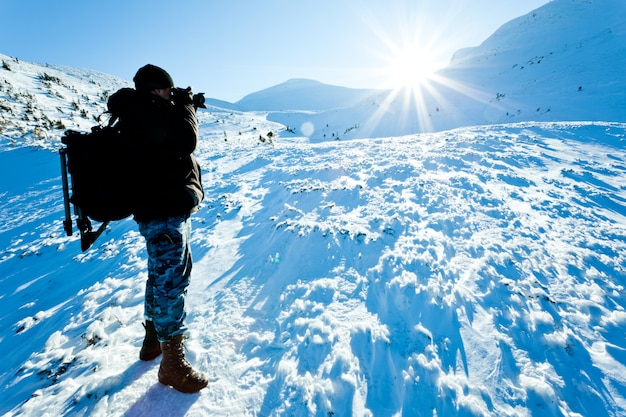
159;334;209;394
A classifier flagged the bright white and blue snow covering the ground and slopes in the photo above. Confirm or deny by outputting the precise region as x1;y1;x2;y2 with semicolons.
0;0;626;417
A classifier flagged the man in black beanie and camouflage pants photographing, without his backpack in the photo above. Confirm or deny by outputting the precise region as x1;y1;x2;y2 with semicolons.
108;65;208;393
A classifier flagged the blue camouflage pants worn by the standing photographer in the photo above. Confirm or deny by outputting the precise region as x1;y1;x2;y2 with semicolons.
137;215;192;342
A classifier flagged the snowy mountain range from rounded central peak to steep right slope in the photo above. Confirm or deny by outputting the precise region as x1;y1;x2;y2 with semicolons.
233;0;626;139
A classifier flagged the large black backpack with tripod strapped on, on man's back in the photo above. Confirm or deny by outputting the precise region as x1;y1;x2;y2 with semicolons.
59;89;134;252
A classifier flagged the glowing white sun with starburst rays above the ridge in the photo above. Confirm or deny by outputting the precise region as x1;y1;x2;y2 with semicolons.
354;6;494;133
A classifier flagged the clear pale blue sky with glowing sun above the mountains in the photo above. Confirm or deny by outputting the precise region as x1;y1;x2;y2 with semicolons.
0;0;548;102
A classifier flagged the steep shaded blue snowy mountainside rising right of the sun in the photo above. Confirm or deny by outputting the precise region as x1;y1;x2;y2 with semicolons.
427;0;626;127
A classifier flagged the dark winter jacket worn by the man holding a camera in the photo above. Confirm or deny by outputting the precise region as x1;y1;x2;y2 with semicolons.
109;89;204;221
